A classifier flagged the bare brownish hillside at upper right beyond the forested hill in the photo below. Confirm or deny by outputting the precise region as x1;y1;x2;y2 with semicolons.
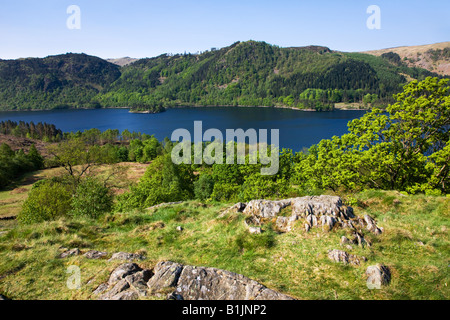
363;41;450;76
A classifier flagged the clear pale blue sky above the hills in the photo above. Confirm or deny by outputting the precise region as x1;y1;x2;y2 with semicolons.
0;0;450;59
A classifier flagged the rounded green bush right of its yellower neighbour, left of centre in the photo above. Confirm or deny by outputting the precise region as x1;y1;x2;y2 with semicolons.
70;177;113;218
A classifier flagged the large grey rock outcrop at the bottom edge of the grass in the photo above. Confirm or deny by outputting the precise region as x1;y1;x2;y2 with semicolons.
93;261;293;300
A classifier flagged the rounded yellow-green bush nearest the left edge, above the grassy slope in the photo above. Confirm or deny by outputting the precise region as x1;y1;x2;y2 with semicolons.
17;180;72;224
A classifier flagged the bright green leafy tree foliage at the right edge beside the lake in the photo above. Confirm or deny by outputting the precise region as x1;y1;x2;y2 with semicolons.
294;77;450;194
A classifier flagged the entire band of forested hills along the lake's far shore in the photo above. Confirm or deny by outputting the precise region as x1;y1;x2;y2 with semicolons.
0;41;440;112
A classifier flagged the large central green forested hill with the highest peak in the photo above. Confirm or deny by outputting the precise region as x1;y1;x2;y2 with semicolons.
99;41;433;109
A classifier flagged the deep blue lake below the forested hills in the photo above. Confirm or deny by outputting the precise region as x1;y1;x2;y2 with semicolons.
0;107;366;151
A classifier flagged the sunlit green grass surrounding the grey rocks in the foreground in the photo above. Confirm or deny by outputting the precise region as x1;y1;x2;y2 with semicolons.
0;191;450;300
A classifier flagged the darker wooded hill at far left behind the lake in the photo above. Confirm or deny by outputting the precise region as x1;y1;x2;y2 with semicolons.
0;53;121;110
